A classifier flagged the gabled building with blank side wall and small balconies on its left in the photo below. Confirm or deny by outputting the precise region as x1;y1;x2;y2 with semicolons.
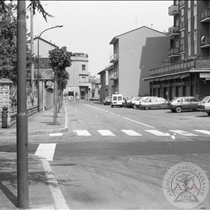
110;26;170;96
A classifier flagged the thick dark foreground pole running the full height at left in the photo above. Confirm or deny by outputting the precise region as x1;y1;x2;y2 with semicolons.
16;0;29;209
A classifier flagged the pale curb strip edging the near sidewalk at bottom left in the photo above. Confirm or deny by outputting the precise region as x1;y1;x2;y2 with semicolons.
40;157;69;210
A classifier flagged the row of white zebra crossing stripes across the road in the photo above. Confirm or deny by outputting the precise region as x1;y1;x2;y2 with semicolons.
50;129;210;139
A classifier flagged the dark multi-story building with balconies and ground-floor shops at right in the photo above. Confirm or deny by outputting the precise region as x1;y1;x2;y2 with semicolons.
143;0;210;99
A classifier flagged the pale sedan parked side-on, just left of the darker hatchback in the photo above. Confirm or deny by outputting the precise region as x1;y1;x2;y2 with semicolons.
140;97;168;109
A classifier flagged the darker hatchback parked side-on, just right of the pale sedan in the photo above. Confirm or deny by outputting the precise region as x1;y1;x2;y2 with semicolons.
168;96;200;113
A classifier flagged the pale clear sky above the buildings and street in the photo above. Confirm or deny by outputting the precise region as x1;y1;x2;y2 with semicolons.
27;0;173;76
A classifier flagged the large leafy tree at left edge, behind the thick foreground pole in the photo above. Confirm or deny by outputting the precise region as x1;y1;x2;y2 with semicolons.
0;3;32;84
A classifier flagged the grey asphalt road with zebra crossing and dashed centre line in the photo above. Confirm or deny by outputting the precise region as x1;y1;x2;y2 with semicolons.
1;102;210;209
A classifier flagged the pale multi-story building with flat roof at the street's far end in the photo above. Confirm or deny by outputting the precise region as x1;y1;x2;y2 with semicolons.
65;53;91;99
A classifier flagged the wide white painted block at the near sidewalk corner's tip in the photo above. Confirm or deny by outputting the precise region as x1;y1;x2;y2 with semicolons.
35;143;56;161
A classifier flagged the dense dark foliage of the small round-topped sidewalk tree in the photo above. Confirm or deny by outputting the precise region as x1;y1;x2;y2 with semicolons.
49;47;72;90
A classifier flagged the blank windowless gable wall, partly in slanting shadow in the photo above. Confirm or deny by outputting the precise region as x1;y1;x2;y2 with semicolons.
118;27;169;96
